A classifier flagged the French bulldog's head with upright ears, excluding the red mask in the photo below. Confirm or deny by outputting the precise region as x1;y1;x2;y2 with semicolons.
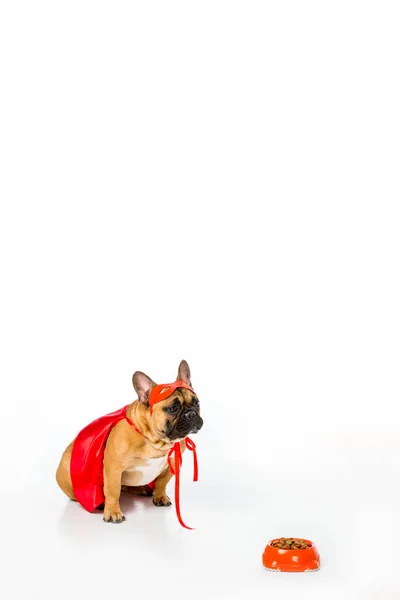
132;360;203;441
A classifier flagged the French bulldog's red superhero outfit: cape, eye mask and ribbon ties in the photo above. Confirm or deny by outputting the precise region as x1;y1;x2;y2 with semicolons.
70;381;198;529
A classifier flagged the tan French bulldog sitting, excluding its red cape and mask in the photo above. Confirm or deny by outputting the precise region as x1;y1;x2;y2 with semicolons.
56;360;203;523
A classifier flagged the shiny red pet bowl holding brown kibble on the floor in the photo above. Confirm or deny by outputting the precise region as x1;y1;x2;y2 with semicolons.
262;538;320;573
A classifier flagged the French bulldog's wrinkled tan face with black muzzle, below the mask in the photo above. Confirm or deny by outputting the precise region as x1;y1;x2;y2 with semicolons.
160;389;203;441
